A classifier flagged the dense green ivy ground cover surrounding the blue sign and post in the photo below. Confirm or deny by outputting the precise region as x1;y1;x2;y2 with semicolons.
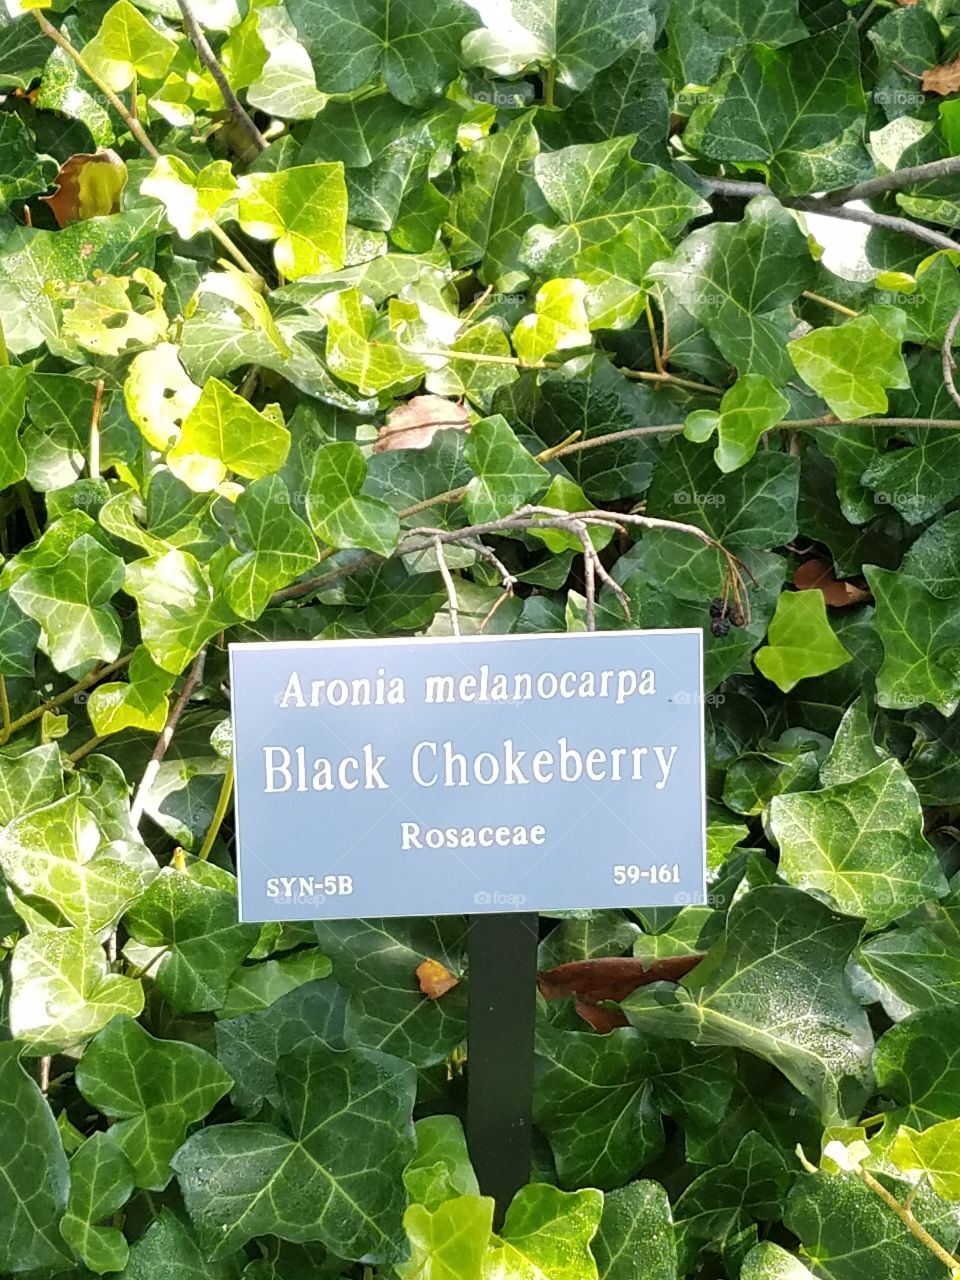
7;0;960;1280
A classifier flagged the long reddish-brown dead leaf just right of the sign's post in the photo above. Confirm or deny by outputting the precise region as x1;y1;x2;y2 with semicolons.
536;954;703;1034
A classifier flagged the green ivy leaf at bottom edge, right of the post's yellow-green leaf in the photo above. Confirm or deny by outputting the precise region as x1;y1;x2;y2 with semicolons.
591;1181;677;1280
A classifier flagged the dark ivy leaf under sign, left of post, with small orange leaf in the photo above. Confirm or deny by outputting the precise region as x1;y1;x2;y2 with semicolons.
315;916;466;1068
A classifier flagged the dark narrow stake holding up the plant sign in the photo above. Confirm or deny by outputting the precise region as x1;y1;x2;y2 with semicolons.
467;913;538;1226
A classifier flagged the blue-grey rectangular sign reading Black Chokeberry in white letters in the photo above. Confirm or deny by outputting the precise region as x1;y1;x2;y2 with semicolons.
230;628;705;920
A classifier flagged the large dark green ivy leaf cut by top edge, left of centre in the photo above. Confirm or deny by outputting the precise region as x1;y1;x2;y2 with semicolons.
287;0;477;105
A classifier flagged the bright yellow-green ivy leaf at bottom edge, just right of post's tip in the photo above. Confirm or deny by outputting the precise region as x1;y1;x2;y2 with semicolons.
488;1183;603;1280
